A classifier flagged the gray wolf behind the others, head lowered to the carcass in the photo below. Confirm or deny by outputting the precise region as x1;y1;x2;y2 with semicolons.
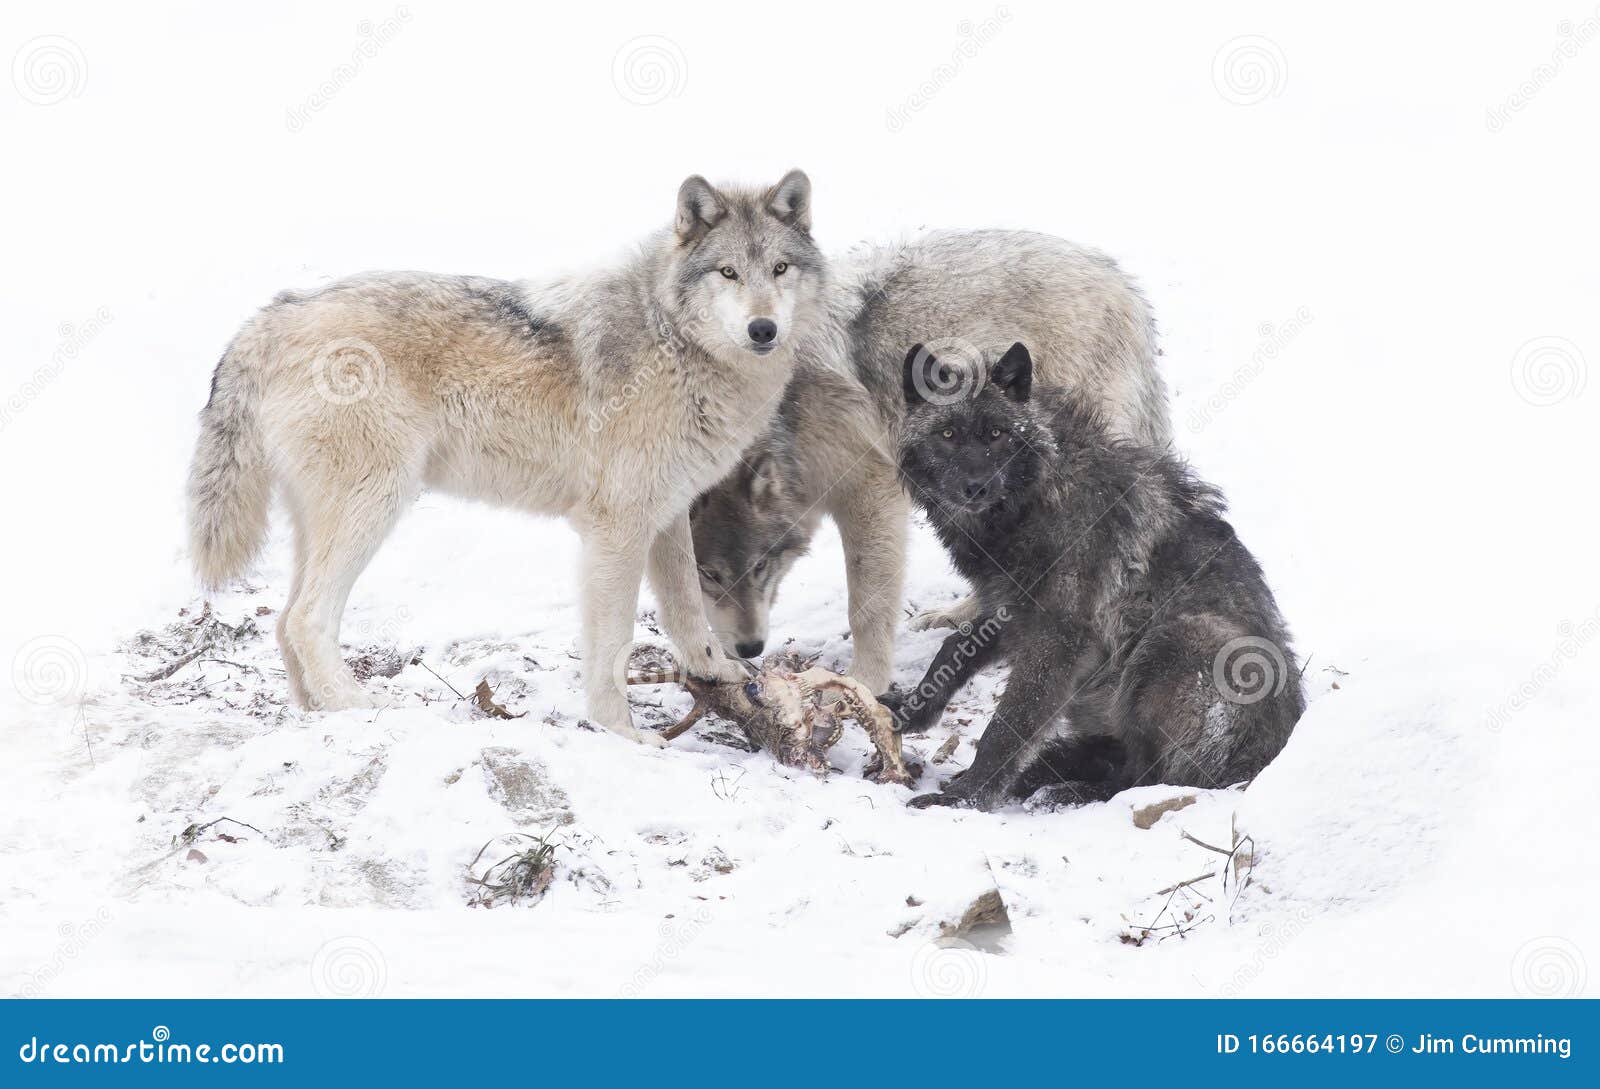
691;230;1170;692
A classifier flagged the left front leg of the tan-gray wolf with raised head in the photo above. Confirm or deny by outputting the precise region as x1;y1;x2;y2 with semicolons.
582;528;666;745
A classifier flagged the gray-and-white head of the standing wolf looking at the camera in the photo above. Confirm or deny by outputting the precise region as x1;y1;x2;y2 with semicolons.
674;171;822;355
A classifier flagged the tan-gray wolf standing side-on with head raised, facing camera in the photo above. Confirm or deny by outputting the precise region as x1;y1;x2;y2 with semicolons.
189;171;842;740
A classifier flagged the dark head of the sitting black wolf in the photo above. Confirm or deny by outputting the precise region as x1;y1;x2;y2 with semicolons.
899;344;1038;515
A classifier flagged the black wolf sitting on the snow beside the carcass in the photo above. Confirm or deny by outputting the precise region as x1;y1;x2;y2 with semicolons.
885;344;1306;809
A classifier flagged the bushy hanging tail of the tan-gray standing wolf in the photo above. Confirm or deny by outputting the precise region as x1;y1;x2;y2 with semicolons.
189;341;272;588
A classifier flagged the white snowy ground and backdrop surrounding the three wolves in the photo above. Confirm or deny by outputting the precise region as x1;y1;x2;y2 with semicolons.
0;0;1600;996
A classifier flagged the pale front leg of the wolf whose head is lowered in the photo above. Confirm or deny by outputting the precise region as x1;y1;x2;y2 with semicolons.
832;467;910;692
